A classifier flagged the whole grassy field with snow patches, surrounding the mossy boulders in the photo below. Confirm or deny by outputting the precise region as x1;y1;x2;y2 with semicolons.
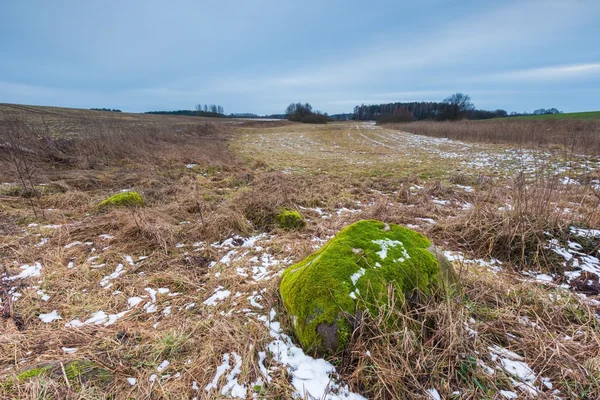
0;106;600;399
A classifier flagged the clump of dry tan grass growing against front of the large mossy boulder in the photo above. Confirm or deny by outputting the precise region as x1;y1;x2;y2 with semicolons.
340;290;473;399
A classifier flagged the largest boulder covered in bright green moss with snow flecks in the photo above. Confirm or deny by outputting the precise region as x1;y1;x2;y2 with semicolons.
279;220;457;354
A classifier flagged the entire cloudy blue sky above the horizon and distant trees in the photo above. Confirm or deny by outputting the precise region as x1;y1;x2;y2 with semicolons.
0;0;600;114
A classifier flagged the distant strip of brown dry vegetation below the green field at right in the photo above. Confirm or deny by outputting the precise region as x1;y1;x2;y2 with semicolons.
390;119;600;154
